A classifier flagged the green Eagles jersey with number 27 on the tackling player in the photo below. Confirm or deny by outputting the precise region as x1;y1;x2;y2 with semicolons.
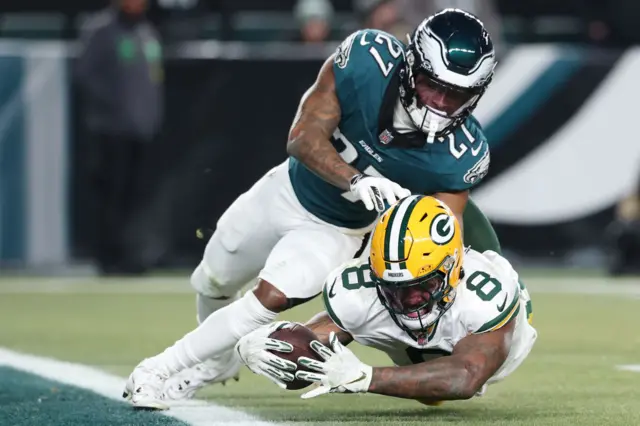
289;30;489;229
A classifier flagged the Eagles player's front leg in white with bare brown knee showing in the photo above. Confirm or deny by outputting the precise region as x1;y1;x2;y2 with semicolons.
129;223;362;405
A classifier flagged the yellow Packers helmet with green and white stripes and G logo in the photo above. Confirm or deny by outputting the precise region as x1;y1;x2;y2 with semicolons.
369;195;464;339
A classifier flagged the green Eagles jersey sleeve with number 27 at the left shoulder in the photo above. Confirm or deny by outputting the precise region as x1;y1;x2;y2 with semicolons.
333;29;404;115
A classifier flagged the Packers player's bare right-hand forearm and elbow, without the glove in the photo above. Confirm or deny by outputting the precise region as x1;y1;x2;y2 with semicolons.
368;318;516;401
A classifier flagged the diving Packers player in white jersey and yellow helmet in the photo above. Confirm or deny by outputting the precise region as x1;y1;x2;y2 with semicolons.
236;195;537;405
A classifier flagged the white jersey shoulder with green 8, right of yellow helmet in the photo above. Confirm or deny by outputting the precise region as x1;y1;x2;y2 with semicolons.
454;250;520;334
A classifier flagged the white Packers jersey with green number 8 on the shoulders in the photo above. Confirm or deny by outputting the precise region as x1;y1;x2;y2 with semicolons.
323;249;537;390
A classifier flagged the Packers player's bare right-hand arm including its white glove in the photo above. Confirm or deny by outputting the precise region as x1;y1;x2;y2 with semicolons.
296;319;515;403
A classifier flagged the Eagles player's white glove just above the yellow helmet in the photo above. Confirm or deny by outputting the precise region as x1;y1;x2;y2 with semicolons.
349;174;411;212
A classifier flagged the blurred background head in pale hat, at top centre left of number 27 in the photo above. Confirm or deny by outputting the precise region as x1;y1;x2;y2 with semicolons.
294;0;333;43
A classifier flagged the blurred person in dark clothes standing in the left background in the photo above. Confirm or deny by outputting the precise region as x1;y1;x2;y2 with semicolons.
75;0;163;274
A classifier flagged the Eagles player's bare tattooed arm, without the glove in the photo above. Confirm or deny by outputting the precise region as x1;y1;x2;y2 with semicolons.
287;55;359;190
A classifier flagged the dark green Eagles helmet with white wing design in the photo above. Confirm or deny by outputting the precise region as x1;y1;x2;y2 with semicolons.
400;9;496;137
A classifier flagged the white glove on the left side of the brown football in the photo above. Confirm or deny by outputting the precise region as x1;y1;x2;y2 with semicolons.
235;321;297;389
